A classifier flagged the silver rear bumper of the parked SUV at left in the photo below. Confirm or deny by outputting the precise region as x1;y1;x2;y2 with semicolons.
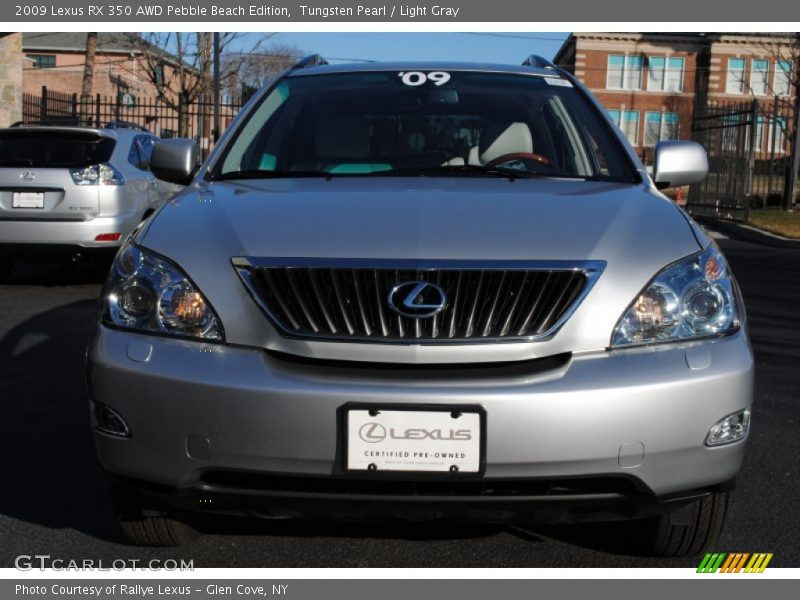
0;213;141;254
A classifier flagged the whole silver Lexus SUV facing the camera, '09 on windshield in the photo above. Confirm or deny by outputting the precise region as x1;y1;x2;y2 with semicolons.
88;55;753;556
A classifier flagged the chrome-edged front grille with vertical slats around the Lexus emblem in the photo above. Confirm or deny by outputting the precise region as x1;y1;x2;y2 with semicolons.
234;259;603;342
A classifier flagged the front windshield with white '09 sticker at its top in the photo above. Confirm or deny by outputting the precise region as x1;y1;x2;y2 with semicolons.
211;71;638;182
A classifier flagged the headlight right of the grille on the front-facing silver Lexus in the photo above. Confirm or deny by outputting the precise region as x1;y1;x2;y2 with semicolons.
611;244;740;346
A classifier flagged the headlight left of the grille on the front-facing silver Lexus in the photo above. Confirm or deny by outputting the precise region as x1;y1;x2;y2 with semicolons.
103;242;223;341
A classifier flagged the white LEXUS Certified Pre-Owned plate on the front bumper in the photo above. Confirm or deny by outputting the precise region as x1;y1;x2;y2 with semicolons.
346;407;483;473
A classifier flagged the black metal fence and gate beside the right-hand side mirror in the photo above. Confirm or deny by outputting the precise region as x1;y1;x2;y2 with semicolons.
687;98;795;221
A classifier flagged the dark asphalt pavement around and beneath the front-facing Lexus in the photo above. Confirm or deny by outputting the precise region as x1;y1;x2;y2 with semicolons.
0;234;800;567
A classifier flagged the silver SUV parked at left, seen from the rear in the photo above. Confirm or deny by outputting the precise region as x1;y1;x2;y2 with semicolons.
0;122;180;278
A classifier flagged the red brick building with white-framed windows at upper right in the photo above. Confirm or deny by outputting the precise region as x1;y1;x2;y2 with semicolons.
555;33;798;160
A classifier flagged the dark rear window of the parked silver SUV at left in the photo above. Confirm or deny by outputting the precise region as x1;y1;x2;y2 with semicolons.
0;129;116;168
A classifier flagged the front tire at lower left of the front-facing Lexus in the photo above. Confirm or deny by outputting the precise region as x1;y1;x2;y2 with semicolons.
112;487;201;547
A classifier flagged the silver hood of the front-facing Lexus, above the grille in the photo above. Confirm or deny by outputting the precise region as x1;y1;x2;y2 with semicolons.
139;177;700;364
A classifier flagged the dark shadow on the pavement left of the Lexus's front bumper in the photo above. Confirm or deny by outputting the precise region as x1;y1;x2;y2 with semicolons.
0;296;121;541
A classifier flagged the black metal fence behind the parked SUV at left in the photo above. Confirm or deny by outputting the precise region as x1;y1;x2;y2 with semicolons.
22;87;242;147
